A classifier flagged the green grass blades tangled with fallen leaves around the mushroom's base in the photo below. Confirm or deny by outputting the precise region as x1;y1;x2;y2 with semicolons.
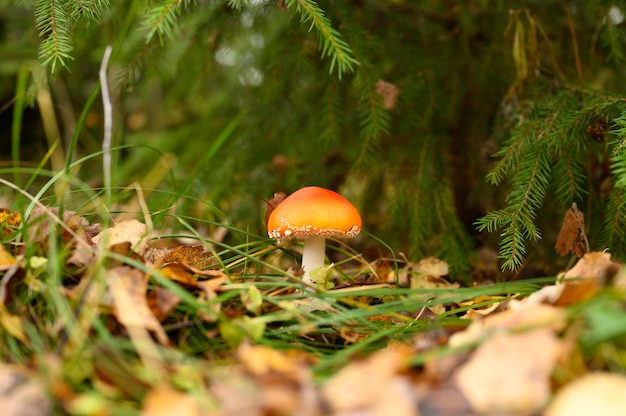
0;154;560;414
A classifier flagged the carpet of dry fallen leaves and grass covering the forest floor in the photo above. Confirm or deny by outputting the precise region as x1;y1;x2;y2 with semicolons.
0;207;626;416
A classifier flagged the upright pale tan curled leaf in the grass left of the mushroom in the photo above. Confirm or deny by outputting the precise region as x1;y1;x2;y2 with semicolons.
107;266;169;345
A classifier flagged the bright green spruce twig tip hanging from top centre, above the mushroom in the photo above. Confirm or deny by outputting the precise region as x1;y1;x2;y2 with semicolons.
286;0;359;79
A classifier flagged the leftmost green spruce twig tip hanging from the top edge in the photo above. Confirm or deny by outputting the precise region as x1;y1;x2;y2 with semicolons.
35;0;73;73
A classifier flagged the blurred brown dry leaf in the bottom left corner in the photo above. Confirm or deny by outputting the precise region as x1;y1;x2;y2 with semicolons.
0;364;52;416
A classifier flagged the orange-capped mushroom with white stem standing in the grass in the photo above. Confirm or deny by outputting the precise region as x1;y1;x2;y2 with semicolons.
267;186;361;284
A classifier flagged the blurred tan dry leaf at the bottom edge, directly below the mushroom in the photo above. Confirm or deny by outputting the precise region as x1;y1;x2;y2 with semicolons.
322;346;419;416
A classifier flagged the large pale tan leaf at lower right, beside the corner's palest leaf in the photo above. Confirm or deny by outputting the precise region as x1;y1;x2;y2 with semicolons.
455;328;561;415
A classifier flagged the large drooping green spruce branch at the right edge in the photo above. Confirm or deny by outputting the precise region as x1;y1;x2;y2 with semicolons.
477;88;626;270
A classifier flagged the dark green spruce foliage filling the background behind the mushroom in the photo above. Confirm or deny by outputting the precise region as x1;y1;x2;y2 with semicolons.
6;0;626;279
